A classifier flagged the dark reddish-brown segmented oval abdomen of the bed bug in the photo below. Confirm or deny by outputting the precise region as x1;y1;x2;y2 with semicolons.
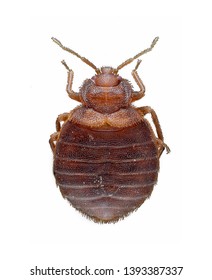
54;121;159;222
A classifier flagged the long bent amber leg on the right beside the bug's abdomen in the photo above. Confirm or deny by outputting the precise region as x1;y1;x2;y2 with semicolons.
138;106;170;155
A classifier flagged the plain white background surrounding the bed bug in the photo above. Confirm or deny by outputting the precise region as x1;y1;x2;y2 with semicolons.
1;0;211;279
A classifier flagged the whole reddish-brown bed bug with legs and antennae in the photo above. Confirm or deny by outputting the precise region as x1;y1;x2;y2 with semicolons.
49;37;170;223
